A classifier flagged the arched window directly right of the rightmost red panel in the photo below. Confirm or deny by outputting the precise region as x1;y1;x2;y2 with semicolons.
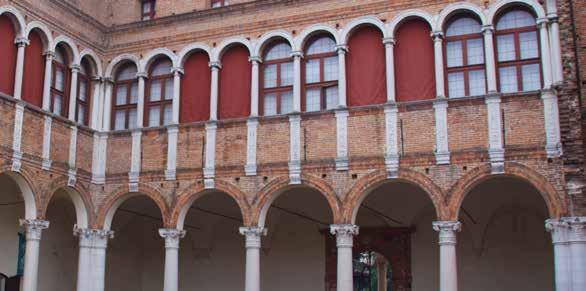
445;17;486;98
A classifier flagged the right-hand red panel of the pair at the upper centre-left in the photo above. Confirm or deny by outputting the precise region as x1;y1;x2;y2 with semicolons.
218;46;252;119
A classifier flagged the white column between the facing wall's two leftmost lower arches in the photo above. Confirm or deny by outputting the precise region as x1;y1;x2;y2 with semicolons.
159;228;185;291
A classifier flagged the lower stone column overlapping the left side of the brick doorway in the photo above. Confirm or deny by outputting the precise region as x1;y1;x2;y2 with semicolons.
330;224;358;291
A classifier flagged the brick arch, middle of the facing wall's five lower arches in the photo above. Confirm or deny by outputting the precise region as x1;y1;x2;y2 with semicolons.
251;174;342;227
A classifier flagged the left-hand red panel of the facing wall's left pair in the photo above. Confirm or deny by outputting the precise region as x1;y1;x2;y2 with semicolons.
179;52;211;123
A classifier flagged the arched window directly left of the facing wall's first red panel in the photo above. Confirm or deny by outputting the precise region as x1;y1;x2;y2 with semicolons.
144;59;173;127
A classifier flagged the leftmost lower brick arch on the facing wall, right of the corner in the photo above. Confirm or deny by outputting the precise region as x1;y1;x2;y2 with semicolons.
94;183;170;229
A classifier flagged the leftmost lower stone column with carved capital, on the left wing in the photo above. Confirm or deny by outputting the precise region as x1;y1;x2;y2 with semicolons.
20;219;49;291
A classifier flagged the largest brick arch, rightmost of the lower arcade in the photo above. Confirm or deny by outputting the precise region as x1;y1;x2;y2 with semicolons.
448;162;567;220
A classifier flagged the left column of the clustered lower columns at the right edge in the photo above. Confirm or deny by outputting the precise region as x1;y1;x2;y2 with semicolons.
545;219;572;291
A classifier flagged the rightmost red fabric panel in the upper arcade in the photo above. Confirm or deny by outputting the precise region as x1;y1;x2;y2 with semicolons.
395;20;436;101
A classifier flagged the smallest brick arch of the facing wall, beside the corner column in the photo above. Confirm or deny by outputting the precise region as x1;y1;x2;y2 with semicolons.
95;184;169;230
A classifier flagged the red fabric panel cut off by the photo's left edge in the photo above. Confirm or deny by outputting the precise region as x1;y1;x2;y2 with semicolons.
0;16;17;96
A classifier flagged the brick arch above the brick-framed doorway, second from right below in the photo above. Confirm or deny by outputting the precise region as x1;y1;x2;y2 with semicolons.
344;169;447;224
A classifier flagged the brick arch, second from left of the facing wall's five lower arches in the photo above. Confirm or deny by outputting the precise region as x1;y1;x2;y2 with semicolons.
169;180;251;228
